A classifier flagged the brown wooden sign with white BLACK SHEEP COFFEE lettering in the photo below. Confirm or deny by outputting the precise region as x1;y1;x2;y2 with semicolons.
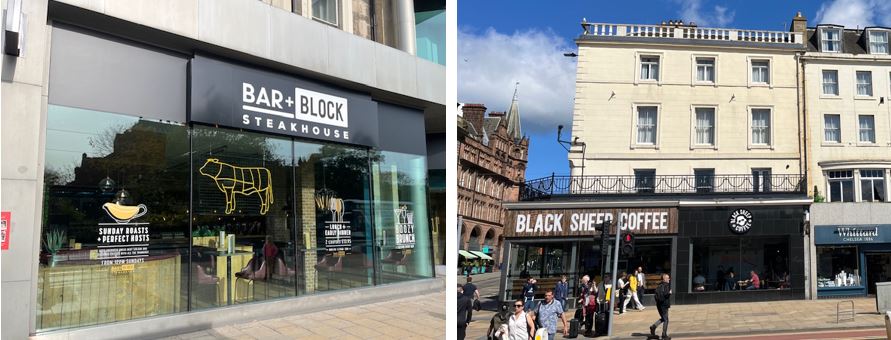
504;208;678;237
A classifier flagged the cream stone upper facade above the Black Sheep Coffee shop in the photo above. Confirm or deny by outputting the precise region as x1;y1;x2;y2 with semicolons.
569;21;805;191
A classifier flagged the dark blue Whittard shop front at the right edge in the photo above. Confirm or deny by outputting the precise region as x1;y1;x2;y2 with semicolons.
814;224;891;297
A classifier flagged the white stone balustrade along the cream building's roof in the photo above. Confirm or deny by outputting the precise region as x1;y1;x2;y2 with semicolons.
582;22;804;45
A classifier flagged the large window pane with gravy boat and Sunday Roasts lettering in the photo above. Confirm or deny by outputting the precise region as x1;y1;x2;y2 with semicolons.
39;105;189;331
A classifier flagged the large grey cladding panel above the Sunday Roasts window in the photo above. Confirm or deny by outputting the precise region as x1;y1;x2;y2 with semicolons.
49;26;188;122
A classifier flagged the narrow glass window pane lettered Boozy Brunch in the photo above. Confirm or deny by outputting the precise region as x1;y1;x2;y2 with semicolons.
372;152;433;283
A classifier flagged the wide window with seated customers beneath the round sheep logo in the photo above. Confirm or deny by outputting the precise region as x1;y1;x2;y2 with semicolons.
689;237;790;292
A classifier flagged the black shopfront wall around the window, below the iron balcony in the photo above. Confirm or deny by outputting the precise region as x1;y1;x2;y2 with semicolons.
673;205;806;304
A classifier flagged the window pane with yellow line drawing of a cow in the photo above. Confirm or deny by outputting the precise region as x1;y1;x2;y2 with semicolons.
190;126;302;309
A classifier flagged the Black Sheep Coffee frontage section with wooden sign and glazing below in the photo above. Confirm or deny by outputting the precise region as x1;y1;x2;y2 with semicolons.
499;203;679;301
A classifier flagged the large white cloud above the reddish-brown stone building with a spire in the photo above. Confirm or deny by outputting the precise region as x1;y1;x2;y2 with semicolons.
458;28;576;134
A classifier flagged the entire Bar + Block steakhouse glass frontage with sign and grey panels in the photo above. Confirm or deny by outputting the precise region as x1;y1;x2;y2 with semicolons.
34;25;433;332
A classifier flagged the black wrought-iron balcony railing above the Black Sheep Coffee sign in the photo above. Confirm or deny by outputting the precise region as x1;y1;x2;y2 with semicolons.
520;174;807;201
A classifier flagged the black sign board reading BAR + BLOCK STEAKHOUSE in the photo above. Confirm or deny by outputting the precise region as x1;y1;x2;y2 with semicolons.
189;56;378;146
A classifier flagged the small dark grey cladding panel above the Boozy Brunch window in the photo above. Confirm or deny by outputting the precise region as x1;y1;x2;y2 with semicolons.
377;102;427;155
